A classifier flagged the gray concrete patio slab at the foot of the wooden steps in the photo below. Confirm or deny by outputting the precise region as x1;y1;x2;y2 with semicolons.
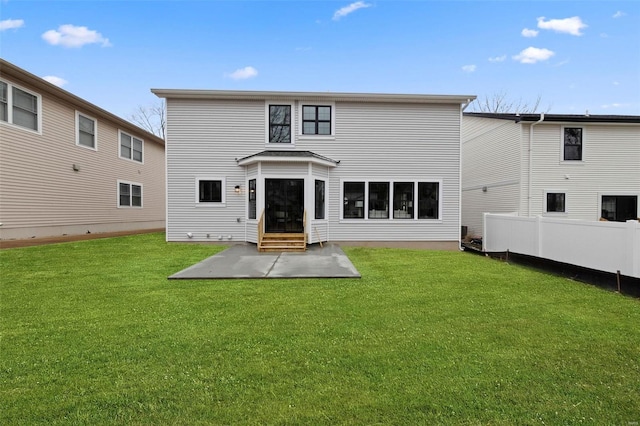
169;244;360;280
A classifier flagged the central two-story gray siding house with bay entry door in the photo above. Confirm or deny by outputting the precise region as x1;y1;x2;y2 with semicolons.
152;89;475;249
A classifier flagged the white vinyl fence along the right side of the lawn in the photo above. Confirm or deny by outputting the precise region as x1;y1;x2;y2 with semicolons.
482;213;640;278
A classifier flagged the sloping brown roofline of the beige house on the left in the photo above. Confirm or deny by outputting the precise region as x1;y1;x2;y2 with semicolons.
0;58;164;146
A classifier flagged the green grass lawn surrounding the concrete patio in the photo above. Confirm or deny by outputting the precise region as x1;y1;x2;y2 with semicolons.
0;234;640;426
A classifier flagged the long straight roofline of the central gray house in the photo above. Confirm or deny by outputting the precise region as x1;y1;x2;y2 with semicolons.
151;89;476;104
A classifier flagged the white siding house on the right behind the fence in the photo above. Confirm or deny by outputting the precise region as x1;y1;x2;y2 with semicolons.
462;113;640;236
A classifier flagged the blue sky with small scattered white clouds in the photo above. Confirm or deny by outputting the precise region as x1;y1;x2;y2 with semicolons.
0;0;640;118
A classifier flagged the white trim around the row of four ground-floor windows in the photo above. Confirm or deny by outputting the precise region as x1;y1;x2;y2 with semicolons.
340;177;444;223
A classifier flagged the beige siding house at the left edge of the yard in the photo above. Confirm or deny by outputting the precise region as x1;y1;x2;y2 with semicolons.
0;60;165;240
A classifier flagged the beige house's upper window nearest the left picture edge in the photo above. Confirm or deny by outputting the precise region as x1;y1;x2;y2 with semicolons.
0;81;41;132
